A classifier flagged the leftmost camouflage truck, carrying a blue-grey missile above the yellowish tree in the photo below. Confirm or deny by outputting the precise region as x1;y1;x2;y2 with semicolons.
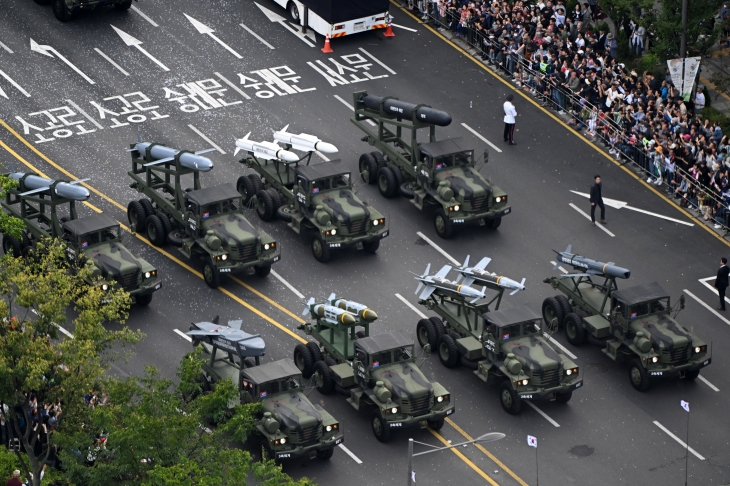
1;173;162;306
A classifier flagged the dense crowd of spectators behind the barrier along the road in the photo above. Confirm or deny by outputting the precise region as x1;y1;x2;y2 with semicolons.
414;0;730;228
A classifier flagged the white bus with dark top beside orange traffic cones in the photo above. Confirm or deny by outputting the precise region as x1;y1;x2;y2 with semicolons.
274;0;389;39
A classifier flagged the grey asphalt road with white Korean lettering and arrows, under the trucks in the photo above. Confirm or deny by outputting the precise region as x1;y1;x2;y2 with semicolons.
0;0;730;486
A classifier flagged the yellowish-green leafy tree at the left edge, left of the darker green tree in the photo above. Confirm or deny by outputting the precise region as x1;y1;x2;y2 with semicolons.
0;240;140;486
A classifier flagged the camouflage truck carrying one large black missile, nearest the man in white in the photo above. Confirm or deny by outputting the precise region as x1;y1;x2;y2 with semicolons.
351;91;512;238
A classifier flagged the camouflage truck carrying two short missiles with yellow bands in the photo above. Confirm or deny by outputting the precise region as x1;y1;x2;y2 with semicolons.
294;294;454;442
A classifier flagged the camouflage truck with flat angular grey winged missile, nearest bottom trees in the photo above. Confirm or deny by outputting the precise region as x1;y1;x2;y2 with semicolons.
187;318;344;462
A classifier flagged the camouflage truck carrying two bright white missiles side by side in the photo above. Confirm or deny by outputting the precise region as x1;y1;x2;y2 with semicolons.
236;126;389;263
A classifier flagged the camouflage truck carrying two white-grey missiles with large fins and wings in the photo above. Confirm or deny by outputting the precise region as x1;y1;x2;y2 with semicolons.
416;257;583;415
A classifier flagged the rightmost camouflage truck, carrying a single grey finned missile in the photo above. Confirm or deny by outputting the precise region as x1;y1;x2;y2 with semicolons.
542;245;712;391
